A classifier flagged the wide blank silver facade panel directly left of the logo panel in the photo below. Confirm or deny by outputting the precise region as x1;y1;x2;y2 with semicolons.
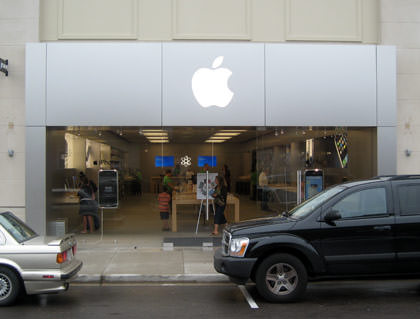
47;43;161;126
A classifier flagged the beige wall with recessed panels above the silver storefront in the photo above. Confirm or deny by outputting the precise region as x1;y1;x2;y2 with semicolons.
40;0;380;43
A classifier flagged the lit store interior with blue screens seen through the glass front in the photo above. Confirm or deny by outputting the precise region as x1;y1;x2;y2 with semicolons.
46;127;377;236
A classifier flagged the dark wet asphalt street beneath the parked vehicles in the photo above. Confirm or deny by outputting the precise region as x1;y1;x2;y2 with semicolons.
0;280;420;319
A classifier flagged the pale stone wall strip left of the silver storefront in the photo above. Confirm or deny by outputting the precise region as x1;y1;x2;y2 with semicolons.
0;0;39;219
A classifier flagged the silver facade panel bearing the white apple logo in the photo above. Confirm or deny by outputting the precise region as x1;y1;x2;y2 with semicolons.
162;42;264;126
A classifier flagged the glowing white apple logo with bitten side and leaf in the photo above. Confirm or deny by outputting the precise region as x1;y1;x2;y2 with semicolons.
191;56;233;107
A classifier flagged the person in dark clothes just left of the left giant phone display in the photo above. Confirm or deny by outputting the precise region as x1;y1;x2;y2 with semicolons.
77;176;98;234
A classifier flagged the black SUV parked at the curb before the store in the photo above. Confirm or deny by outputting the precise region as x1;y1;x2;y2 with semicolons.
214;175;420;302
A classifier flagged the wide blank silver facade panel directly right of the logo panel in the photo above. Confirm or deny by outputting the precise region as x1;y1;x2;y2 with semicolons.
266;44;377;126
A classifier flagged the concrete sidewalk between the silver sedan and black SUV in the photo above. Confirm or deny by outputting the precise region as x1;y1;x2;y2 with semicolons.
76;235;229;283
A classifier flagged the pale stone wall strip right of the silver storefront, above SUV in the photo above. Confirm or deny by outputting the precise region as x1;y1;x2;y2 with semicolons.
380;0;420;174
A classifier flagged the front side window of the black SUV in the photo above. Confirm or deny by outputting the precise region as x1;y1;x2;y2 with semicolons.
332;187;388;218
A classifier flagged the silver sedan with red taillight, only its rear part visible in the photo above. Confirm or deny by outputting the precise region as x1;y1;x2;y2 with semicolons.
0;212;82;306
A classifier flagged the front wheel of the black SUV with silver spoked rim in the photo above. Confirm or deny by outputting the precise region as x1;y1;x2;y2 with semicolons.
256;254;308;302
